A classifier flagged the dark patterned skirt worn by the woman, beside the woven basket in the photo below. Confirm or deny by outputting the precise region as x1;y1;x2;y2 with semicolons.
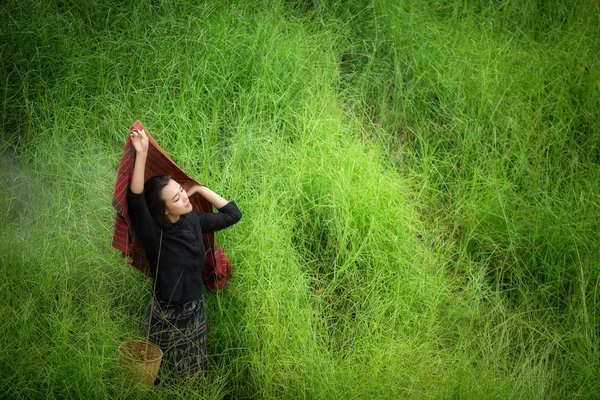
145;297;207;377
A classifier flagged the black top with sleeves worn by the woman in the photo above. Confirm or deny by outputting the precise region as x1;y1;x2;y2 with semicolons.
127;190;242;303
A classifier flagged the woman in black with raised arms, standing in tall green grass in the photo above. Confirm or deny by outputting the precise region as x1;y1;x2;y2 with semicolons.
127;129;242;376
